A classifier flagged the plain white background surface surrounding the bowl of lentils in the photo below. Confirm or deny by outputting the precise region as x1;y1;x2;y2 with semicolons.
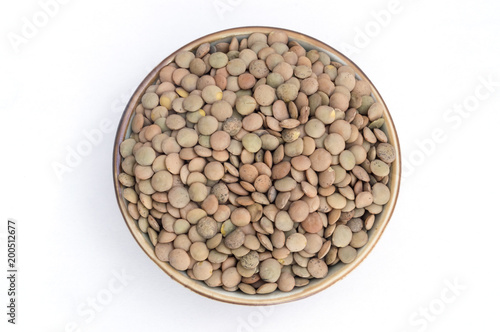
0;0;500;332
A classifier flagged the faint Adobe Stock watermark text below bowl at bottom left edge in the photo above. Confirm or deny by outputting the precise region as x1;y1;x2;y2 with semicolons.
64;270;135;332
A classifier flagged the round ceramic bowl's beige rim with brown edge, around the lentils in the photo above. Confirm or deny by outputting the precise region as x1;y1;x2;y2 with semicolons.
113;27;401;305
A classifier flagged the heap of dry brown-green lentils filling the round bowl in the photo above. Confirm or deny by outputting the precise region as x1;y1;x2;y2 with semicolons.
118;31;396;294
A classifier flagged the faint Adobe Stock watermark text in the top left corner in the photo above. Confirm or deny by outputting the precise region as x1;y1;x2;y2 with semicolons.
7;0;70;53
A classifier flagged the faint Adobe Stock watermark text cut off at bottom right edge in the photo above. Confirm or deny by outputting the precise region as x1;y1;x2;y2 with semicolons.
408;278;467;332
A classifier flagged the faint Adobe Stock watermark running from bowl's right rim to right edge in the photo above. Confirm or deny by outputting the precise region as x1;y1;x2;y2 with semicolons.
401;74;500;181
